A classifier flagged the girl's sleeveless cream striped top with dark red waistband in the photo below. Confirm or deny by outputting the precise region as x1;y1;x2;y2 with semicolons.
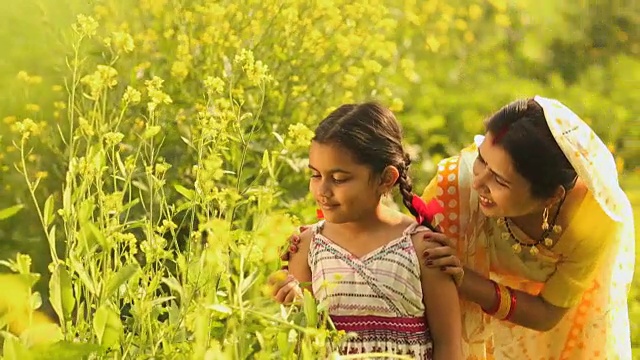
308;221;433;359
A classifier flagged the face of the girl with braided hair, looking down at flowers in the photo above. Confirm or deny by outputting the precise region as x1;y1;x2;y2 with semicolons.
309;141;385;224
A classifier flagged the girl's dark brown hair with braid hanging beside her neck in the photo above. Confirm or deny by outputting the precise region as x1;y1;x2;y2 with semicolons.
312;102;435;231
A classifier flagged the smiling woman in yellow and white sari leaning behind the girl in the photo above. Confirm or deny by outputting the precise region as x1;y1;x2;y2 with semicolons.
276;96;635;360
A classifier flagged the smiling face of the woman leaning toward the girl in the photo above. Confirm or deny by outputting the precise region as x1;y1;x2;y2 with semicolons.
472;133;545;217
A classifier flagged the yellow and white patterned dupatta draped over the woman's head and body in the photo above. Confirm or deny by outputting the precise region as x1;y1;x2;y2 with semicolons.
423;96;635;360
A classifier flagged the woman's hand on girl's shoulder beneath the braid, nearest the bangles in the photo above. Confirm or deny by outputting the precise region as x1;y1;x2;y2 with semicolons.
422;232;464;287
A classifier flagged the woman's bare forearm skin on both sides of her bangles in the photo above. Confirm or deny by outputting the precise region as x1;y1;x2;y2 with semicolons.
458;268;567;331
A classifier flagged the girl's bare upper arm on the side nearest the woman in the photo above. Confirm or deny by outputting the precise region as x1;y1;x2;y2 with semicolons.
413;233;462;360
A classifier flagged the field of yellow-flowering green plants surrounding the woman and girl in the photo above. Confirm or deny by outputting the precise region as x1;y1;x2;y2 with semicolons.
0;0;640;360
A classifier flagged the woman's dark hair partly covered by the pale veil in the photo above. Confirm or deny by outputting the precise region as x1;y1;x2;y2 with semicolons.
486;99;577;199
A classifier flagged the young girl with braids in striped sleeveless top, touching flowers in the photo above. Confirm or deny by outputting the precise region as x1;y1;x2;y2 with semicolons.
275;103;462;360
